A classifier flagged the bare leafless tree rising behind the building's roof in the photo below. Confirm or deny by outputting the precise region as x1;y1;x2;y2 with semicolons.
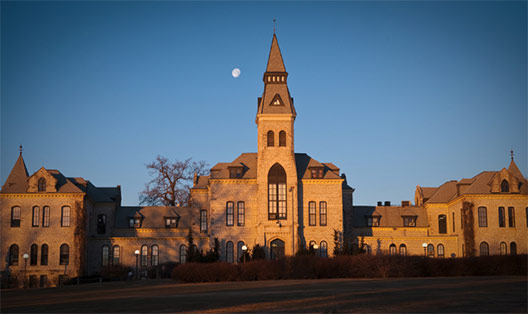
139;155;208;206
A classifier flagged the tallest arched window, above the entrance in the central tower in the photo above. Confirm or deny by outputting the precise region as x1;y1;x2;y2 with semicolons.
268;164;287;220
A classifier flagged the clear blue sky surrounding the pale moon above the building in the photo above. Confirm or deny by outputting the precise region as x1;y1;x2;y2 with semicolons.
0;1;528;205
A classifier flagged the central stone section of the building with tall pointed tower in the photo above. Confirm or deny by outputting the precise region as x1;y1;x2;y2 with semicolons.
191;35;353;261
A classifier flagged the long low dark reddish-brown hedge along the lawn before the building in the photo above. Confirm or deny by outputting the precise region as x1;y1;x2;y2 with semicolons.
172;254;527;282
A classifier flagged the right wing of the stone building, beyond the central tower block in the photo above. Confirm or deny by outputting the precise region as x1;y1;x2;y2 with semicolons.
345;155;528;257
